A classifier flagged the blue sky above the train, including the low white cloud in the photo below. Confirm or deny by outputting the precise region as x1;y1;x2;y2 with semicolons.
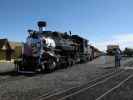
0;0;133;50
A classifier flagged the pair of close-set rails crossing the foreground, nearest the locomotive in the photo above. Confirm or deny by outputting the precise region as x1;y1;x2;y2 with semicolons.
35;69;125;100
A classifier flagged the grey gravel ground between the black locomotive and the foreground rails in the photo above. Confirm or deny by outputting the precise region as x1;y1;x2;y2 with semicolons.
0;55;132;100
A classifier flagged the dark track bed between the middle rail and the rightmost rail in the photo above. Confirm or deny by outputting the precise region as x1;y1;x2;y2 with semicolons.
58;71;133;100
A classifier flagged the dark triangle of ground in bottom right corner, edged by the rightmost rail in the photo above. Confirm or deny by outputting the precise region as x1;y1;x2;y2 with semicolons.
100;71;133;100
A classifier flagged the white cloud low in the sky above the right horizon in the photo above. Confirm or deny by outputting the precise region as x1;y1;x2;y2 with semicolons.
94;33;133;51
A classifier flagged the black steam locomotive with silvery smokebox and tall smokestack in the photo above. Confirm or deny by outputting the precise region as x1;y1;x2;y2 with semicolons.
15;21;89;72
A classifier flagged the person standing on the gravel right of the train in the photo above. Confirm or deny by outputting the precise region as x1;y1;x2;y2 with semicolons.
115;48;121;67
